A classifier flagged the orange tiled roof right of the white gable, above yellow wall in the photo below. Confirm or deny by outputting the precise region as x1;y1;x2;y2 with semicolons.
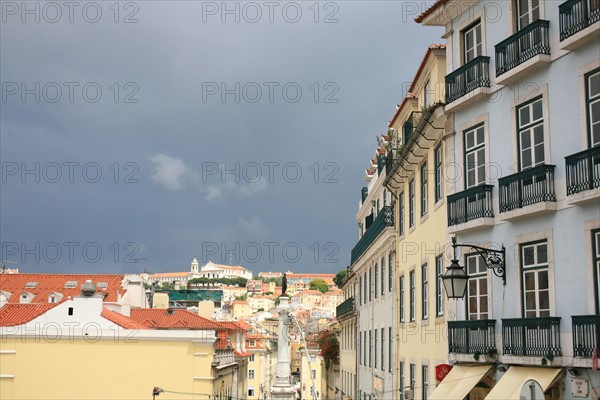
130;308;227;330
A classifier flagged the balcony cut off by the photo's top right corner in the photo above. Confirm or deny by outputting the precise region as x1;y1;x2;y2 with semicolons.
558;0;600;50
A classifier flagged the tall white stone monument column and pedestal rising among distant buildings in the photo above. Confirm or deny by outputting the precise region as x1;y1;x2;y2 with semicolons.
271;296;296;400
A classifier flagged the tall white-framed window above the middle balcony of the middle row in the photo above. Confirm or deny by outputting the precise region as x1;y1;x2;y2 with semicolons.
517;97;544;170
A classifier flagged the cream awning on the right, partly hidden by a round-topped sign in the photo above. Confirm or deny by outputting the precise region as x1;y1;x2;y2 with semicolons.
485;367;560;400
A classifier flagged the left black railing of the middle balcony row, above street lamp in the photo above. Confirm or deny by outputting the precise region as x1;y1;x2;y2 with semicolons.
448;185;494;226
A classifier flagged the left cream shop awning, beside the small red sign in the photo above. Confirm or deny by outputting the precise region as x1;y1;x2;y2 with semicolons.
429;365;492;400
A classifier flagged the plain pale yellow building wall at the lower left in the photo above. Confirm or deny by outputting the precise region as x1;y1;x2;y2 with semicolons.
0;335;214;400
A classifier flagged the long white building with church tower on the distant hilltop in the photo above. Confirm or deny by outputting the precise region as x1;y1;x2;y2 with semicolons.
148;257;252;286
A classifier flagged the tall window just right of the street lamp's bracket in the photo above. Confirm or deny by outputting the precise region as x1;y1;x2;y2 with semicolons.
521;241;550;318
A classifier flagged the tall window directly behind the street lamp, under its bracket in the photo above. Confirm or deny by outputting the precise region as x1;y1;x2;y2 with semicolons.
465;254;489;321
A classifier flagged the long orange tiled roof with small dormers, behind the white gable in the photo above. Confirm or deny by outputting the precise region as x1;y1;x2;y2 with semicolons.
0;274;127;303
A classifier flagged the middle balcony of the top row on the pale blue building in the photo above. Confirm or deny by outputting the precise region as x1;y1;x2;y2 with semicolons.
496;19;550;85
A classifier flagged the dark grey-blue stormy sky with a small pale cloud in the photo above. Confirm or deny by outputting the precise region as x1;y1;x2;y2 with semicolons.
0;1;442;273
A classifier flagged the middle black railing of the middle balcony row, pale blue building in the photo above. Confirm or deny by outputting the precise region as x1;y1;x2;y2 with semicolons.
498;164;556;212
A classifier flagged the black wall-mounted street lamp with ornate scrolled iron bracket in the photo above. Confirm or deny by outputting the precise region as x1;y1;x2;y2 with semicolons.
442;236;506;299
